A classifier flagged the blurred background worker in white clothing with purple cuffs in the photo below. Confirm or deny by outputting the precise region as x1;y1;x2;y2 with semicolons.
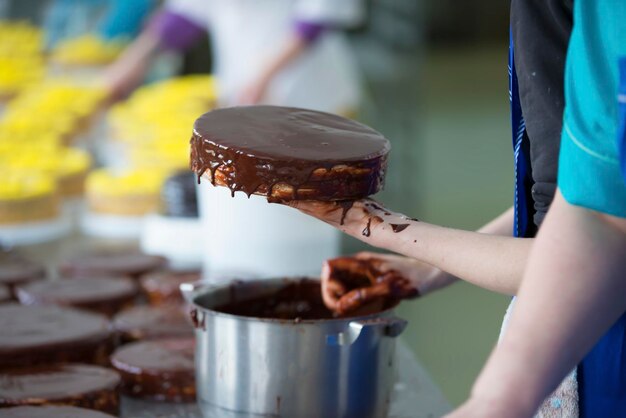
107;0;365;114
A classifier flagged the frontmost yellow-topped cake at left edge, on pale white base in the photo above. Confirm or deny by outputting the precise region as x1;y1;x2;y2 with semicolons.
0;167;59;225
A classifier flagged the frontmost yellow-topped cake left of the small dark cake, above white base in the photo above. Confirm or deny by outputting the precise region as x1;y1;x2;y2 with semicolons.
86;169;165;216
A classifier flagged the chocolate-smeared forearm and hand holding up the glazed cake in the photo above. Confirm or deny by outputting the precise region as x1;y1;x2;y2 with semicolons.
291;200;533;295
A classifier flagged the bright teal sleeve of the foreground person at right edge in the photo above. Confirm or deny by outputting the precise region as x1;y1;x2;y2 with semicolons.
558;0;626;217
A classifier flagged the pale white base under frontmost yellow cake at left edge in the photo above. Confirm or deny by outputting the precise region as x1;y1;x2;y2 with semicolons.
0;213;72;246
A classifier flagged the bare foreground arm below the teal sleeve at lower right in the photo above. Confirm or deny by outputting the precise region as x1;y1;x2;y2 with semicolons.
451;193;626;418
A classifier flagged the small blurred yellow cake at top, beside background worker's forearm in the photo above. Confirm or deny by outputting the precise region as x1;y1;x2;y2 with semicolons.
51;34;128;66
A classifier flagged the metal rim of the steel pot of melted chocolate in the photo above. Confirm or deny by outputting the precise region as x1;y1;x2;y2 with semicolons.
180;276;401;325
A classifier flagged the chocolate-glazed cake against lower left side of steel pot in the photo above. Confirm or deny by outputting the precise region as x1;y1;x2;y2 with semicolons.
111;338;196;402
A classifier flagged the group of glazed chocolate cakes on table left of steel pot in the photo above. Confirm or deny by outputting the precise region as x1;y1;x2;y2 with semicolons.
0;249;200;418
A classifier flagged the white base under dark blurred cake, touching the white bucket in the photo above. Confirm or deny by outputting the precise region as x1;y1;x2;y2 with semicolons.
140;214;203;269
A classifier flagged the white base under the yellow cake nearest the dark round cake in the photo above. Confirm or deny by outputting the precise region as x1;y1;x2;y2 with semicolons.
81;212;145;240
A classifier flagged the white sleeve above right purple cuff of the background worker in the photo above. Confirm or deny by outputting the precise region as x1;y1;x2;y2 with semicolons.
294;0;365;27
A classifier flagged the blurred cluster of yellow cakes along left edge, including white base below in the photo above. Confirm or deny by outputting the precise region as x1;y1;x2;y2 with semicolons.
0;80;103;244
